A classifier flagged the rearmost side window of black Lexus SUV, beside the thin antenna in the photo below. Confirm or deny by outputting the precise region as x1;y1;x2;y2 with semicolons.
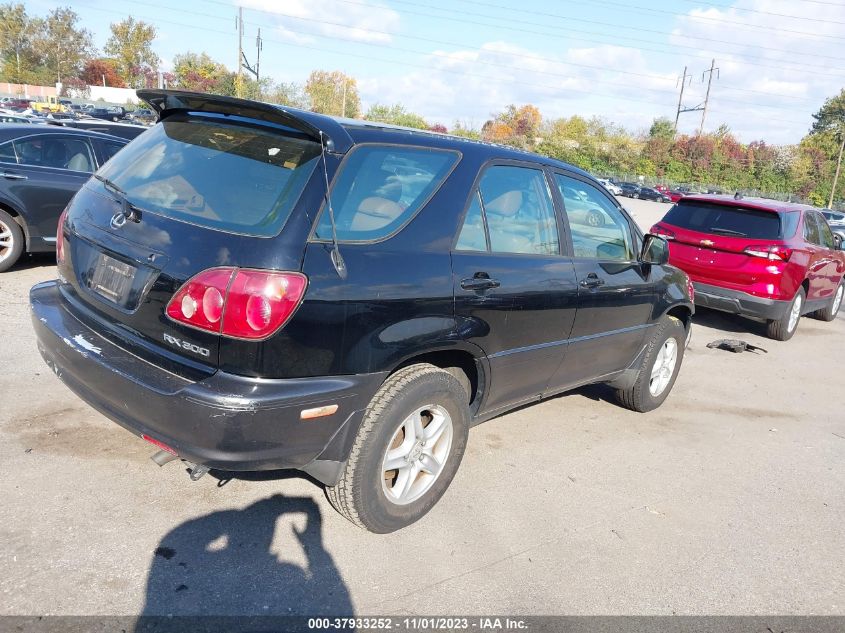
316;145;460;241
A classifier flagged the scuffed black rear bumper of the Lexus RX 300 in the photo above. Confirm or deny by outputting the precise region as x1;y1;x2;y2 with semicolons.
30;282;384;484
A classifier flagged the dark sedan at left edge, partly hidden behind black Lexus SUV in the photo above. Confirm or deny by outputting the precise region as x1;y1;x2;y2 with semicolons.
0;123;126;272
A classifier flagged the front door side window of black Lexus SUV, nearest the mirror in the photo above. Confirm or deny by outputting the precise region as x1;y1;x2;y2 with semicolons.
555;174;634;261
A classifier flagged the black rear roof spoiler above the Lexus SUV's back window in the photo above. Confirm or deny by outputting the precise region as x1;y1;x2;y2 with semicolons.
137;90;354;154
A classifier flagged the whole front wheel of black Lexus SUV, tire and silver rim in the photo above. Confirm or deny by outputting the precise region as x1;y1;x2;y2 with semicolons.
616;316;687;413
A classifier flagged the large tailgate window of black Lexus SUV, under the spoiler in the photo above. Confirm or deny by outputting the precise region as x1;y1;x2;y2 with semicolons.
95;116;320;237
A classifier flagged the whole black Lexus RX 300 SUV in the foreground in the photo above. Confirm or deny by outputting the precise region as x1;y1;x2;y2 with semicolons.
30;90;693;532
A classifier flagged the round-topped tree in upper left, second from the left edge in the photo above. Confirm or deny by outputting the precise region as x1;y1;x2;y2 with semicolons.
36;7;94;83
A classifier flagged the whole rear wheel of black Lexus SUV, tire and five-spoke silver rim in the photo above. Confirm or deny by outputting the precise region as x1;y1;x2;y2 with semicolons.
326;364;470;534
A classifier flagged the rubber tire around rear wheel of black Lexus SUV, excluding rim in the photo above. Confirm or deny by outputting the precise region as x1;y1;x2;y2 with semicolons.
326;363;470;534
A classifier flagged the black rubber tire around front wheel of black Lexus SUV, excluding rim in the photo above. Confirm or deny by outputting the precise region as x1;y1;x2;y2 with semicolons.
616;316;687;413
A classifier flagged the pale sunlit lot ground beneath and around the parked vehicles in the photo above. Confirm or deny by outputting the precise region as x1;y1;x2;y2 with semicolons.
0;200;845;615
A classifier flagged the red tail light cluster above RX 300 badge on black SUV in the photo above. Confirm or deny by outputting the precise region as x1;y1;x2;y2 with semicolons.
166;268;308;340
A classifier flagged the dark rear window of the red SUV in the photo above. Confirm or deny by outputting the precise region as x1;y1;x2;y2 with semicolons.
663;203;782;240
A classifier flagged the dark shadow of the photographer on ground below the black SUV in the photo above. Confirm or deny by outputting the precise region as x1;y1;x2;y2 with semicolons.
136;495;354;620
